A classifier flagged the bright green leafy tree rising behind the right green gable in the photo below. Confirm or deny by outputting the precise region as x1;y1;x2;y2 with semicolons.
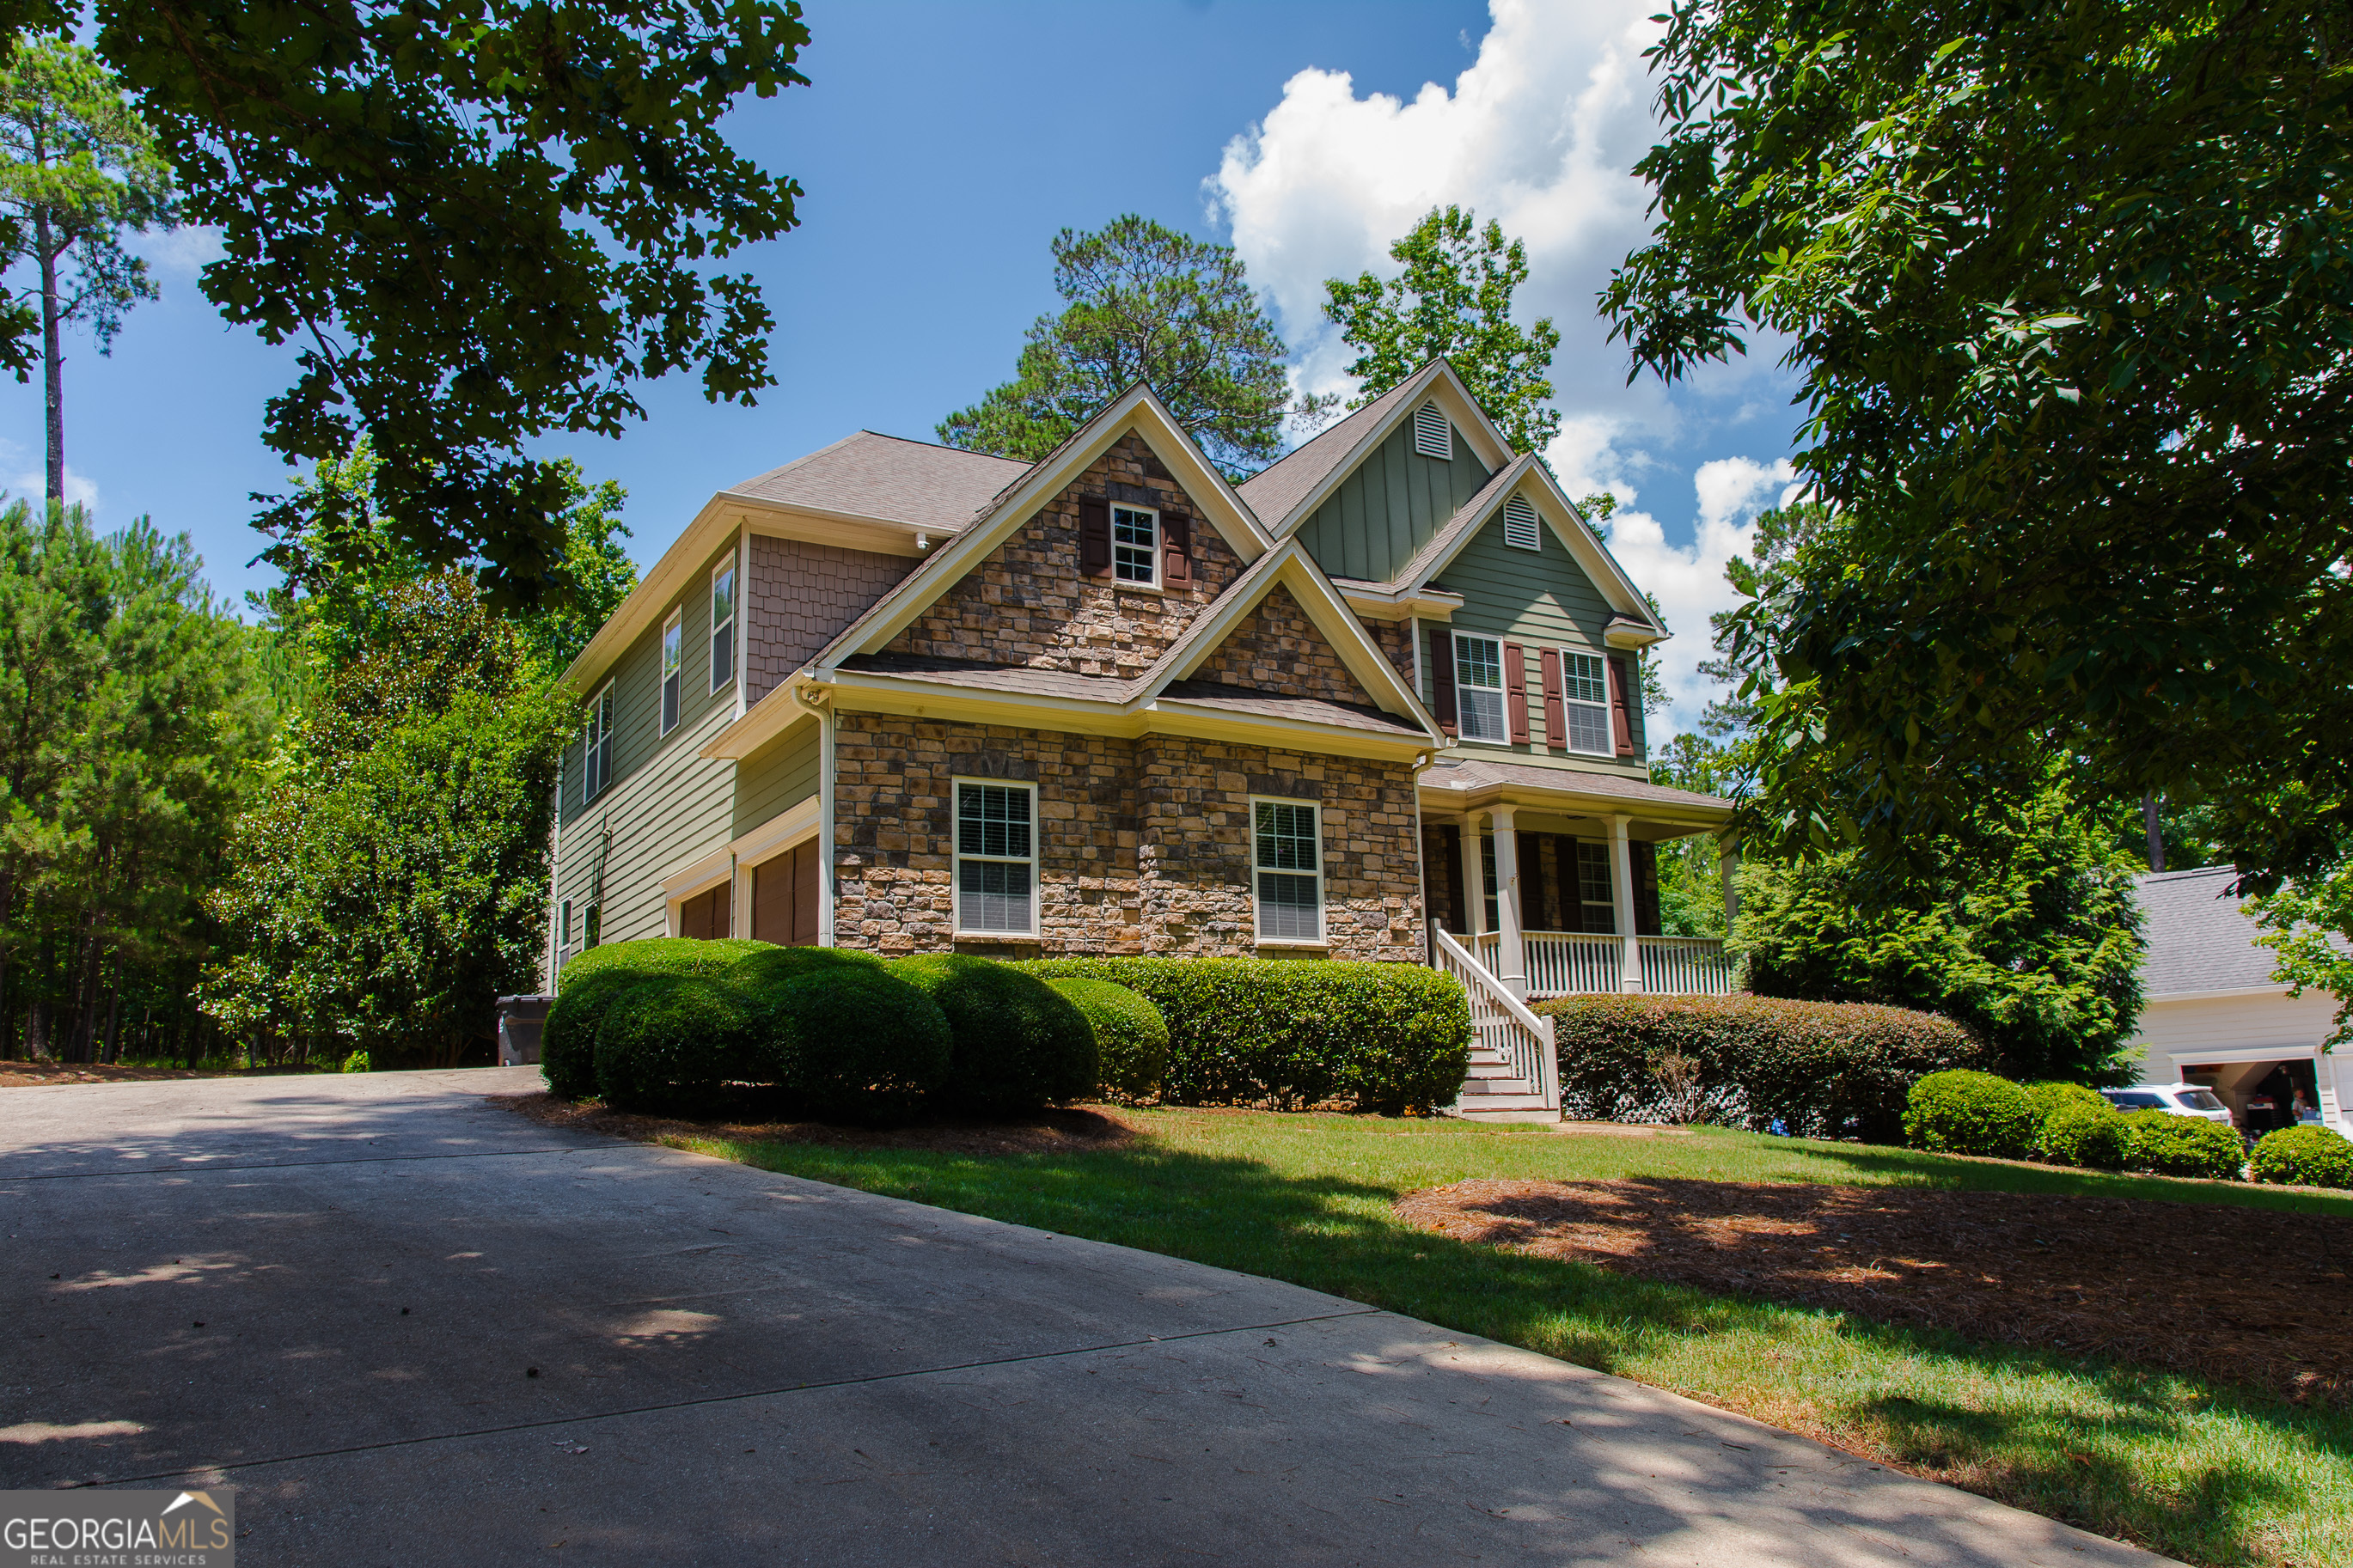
1324;204;1560;454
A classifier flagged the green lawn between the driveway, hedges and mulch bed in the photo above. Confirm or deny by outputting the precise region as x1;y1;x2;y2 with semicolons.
689;1109;2353;1568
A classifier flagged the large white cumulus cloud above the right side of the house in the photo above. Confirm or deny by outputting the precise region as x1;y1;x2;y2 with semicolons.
1205;0;1791;742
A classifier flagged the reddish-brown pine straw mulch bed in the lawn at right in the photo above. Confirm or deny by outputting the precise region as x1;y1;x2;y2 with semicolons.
1396;1178;2353;1403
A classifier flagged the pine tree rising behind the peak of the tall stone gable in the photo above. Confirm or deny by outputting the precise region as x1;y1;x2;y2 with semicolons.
938;214;1289;475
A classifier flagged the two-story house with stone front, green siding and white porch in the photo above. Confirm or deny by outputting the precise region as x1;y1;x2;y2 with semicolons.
548;360;1729;1102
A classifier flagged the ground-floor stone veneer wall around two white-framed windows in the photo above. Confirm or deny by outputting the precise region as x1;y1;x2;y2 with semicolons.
833;712;1423;961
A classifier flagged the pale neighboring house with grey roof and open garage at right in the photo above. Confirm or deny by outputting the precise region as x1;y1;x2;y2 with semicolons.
2134;865;2353;1136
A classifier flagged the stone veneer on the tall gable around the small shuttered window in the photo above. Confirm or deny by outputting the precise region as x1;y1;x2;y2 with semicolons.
884;432;1243;680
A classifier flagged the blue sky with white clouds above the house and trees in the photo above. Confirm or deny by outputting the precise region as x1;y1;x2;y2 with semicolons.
0;0;1798;729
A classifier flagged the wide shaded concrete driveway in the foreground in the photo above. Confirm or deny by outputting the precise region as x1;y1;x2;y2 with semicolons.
0;1067;2160;1568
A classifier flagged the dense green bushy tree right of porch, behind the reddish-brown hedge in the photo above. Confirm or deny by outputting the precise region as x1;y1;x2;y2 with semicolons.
1734;769;2143;1082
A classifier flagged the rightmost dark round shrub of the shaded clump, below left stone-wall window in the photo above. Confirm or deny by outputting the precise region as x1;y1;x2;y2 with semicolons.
889;952;1097;1117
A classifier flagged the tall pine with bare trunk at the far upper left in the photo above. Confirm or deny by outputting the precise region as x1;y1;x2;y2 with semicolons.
0;38;172;505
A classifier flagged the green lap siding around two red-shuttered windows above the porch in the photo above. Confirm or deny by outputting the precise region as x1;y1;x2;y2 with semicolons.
1421;508;1649;771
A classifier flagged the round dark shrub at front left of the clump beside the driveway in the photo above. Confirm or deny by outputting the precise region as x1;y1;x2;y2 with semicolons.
596;975;765;1117
